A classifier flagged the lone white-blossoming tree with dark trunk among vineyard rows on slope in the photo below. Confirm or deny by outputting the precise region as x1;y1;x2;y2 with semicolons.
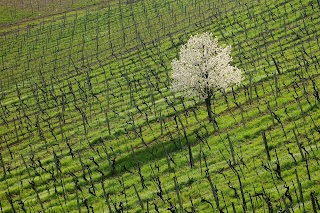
171;33;242;122
